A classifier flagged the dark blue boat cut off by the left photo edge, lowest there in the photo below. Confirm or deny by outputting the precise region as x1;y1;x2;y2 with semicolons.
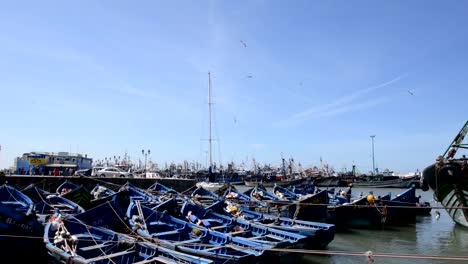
0;183;47;262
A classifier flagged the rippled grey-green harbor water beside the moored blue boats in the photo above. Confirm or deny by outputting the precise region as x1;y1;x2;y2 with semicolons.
236;186;468;264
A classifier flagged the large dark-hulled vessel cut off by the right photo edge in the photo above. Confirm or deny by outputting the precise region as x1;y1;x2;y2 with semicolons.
421;121;468;227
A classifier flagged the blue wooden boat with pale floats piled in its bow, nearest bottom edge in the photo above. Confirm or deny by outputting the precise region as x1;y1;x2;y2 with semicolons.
43;214;212;264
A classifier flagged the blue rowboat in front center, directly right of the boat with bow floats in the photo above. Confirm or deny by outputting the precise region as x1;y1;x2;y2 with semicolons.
126;200;271;263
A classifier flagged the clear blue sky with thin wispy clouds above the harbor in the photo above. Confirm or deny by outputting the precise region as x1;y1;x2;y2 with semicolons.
0;0;468;172
